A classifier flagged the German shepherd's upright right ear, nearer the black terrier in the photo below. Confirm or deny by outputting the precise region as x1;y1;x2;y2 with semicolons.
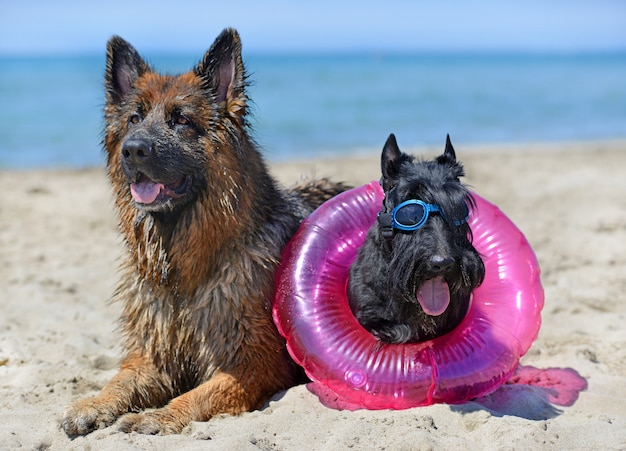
194;28;247;116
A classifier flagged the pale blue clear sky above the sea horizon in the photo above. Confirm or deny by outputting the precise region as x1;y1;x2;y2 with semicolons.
0;0;626;54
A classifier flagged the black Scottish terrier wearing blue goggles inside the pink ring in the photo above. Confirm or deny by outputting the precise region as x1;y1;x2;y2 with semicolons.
348;134;485;343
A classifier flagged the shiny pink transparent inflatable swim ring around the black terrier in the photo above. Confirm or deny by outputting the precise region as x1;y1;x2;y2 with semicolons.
273;182;543;409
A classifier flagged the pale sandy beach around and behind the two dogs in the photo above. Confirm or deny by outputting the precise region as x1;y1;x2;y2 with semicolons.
0;137;626;450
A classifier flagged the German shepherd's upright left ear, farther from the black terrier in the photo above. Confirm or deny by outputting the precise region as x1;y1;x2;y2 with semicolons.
104;36;150;104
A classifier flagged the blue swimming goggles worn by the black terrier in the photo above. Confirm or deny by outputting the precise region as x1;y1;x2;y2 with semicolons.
378;199;469;239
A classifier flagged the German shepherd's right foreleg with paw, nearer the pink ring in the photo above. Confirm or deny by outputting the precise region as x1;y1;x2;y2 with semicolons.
119;373;267;434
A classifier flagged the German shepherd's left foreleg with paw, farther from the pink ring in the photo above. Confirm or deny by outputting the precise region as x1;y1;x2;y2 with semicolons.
61;355;172;436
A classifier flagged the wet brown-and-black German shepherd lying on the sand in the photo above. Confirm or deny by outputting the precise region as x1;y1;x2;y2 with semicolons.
62;29;347;436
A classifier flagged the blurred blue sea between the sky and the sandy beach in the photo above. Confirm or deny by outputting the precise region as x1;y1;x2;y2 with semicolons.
0;53;626;168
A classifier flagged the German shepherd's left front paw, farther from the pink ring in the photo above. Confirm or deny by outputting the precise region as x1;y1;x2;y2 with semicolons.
61;398;119;436
